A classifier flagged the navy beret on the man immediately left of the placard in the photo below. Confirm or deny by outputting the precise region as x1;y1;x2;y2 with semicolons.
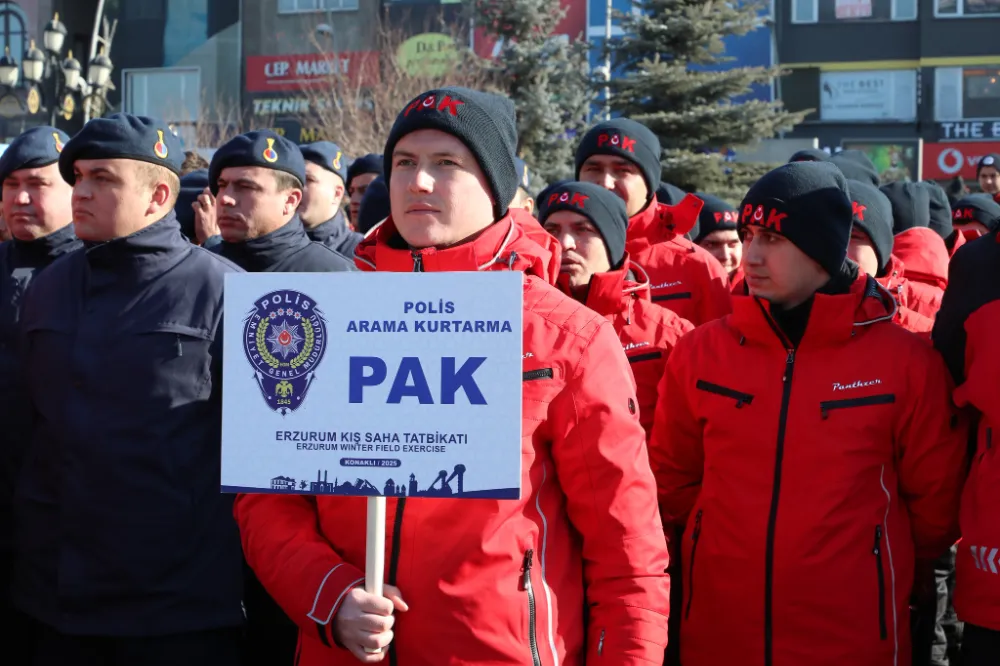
59;113;184;185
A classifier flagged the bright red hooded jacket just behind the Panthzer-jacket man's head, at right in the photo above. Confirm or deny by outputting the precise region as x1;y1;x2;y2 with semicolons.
892;227;950;319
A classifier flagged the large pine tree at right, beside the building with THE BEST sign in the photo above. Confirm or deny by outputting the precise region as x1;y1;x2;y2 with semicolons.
602;0;806;203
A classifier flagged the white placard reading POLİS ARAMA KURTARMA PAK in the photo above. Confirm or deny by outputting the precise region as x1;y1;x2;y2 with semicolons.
222;271;522;499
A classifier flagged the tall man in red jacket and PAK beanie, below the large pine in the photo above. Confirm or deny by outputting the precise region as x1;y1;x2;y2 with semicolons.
576;118;731;326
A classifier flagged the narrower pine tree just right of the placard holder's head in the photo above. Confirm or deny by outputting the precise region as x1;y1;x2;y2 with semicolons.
472;0;593;188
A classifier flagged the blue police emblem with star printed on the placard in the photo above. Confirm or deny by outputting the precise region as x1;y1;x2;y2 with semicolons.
243;290;326;416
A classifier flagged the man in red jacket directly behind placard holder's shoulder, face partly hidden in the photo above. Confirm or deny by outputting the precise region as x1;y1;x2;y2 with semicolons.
539;183;694;437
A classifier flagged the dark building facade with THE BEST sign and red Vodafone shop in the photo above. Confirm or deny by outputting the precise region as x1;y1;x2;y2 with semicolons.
775;0;1000;180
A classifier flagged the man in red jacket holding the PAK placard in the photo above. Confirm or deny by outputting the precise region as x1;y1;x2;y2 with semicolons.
236;88;669;666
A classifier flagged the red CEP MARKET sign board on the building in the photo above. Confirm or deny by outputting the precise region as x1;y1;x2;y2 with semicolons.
246;51;379;92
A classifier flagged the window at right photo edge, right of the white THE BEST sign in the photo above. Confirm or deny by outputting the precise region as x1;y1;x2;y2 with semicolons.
934;66;1000;121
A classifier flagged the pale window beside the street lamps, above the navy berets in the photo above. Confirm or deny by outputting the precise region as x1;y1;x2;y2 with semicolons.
122;67;202;146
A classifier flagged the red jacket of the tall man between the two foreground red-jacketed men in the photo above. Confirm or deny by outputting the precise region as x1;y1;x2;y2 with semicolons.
625;194;732;326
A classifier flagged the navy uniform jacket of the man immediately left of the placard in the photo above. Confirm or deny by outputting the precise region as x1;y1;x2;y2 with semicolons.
13;212;243;636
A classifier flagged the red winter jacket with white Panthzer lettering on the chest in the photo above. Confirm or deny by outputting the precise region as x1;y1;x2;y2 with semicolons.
649;275;966;666
